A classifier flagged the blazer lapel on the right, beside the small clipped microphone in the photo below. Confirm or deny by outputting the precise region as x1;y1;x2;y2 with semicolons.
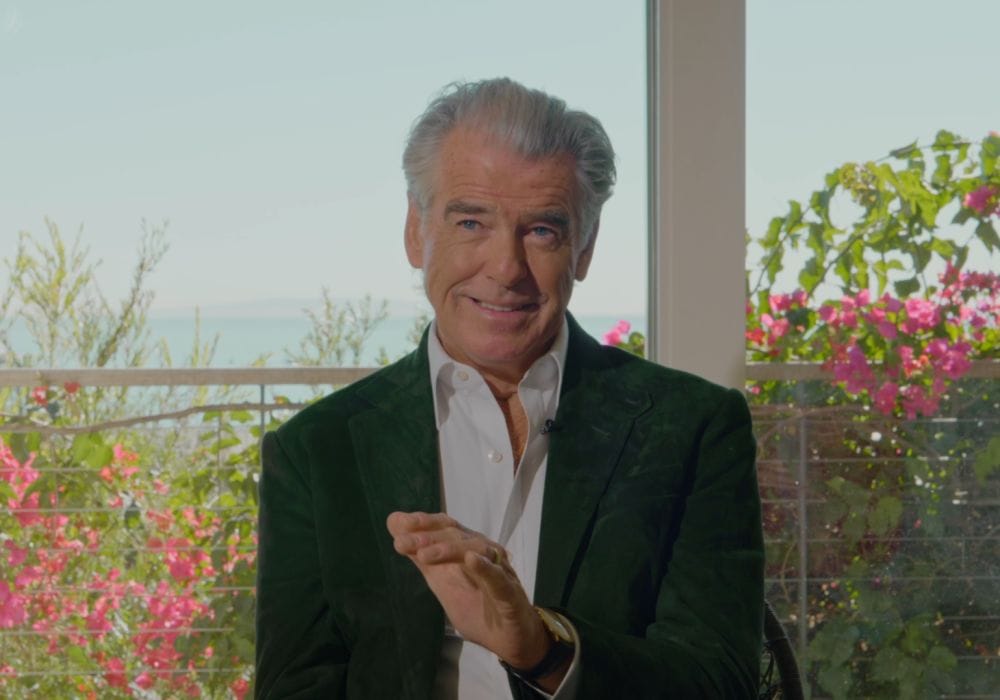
534;314;651;606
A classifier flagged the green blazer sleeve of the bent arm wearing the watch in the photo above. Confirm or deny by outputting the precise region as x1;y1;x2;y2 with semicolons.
562;390;764;699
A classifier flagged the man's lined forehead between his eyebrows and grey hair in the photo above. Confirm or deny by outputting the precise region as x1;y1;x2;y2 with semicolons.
432;128;578;215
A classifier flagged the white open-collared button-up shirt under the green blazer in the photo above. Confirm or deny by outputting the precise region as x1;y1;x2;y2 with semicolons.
427;321;579;700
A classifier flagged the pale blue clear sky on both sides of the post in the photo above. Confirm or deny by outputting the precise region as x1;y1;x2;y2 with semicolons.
0;0;1000;314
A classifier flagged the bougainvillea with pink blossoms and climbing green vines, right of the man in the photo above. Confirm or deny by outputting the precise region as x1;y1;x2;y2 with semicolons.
604;132;1000;698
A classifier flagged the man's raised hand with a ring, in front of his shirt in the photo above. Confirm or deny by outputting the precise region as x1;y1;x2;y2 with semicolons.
386;512;551;669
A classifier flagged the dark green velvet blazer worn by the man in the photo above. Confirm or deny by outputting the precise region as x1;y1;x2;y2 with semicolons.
255;317;764;699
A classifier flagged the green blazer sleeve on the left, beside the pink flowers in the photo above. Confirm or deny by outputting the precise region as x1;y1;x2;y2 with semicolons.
254;433;349;700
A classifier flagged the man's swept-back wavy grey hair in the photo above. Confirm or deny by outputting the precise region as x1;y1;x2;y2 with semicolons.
403;78;616;245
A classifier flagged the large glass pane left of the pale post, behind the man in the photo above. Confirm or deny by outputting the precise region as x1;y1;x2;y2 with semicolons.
0;0;646;698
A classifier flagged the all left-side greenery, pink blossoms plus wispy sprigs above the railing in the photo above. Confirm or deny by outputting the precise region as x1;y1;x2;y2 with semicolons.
0;222;384;699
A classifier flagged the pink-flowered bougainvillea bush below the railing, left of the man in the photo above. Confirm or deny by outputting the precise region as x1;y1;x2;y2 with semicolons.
0;404;256;698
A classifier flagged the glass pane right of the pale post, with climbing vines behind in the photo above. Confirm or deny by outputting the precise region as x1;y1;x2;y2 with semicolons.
747;1;1000;698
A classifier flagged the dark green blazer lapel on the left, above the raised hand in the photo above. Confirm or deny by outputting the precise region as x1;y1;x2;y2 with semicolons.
350;344;444;698
